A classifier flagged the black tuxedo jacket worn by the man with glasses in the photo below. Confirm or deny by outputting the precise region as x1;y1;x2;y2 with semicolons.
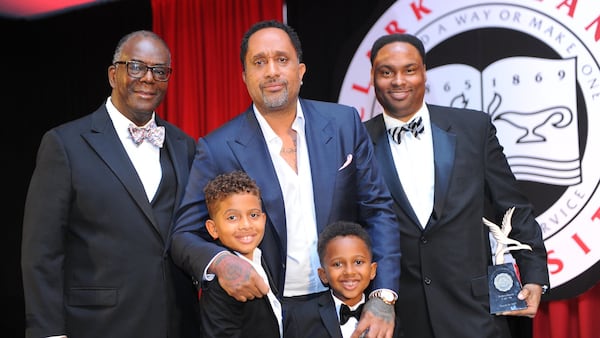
22;104;199;338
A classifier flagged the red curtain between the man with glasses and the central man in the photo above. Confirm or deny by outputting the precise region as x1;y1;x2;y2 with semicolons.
151;0;284;138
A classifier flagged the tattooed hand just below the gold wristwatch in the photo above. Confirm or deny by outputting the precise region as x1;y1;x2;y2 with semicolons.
351;297;396;338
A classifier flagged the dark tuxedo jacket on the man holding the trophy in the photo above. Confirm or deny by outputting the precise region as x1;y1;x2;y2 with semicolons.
365;105;549;338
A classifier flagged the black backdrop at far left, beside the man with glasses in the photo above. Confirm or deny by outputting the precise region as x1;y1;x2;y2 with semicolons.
0;0;152;338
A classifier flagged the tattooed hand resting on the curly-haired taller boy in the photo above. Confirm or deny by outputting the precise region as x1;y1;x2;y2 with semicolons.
209;252;269;302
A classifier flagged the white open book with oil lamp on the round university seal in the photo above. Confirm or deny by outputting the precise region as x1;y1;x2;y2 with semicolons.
425;57;581;186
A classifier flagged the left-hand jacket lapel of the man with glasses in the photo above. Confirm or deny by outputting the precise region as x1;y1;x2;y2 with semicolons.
82;107;160;233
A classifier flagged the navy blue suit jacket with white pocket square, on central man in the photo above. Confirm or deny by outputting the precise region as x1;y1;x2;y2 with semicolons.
172;99;400;297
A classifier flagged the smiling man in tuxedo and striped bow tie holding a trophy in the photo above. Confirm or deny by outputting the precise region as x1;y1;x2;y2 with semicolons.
365;34;549;338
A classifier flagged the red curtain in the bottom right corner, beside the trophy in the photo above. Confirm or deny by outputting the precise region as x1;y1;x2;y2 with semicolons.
533;283;600;338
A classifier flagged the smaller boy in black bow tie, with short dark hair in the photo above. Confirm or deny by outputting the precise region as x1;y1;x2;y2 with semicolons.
284;221;377;338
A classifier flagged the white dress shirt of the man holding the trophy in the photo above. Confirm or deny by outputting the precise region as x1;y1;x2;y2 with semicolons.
383;104;435;228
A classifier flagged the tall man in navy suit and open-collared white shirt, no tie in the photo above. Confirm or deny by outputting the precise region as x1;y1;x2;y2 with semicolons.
172;21;400;338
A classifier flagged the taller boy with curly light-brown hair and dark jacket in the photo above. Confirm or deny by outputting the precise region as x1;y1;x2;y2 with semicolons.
200;171;282;338
